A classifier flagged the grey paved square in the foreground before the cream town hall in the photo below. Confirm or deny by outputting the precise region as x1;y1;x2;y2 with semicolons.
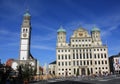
30;75;120;84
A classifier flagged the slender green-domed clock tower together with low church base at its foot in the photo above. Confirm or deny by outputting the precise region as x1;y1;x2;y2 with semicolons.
12;10;37;70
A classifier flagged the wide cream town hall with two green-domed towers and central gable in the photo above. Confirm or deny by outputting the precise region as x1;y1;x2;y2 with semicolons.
49;27;110;76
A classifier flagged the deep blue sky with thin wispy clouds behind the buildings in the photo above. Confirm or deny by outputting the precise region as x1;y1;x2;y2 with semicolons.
0;0;120;66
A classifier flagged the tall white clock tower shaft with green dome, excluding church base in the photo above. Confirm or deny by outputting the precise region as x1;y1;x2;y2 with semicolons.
19;11;31;60
